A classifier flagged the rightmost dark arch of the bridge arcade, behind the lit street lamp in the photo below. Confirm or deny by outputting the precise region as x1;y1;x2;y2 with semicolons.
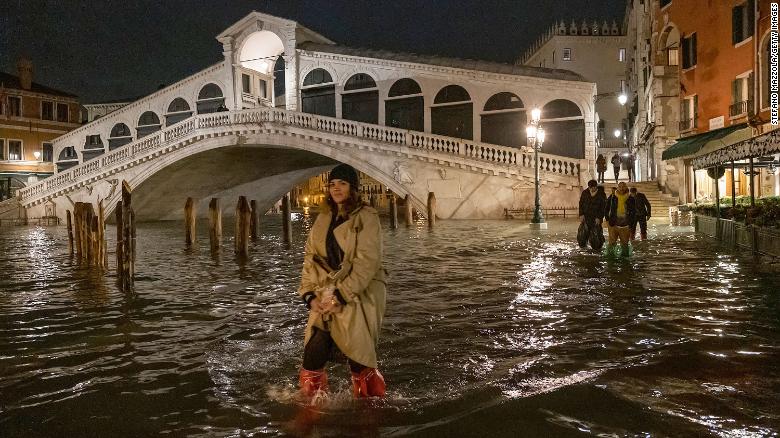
541;99;585;158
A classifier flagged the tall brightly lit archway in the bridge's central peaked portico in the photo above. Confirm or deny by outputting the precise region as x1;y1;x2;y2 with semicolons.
241;30;284;108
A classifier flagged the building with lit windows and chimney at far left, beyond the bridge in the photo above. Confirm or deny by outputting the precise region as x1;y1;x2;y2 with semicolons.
0;59;80;200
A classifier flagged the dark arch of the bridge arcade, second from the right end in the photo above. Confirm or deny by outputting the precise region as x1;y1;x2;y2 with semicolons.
481;92;526;148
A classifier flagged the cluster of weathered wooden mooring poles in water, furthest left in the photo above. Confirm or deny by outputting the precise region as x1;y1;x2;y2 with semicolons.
66;181;135;291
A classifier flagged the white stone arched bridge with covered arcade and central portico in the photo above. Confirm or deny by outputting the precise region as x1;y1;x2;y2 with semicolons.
16;12;597;220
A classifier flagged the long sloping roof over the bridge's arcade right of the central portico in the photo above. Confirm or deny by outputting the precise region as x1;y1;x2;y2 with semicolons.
298;42;590;82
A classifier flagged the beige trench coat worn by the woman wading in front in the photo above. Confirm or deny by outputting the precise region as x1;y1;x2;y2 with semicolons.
298;206;386;368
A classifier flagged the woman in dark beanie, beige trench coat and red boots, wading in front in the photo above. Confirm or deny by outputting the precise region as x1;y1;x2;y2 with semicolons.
298;164;386;398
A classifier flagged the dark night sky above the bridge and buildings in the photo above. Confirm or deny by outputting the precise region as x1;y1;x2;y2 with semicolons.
0;0;626;103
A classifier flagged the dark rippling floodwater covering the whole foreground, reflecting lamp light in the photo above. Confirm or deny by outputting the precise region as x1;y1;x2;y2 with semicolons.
0;216;780;437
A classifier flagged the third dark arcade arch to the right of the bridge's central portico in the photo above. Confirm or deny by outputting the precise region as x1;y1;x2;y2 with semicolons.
385;78;425;132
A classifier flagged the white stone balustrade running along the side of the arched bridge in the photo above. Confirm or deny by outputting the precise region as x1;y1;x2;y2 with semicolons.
19;108;583;202
